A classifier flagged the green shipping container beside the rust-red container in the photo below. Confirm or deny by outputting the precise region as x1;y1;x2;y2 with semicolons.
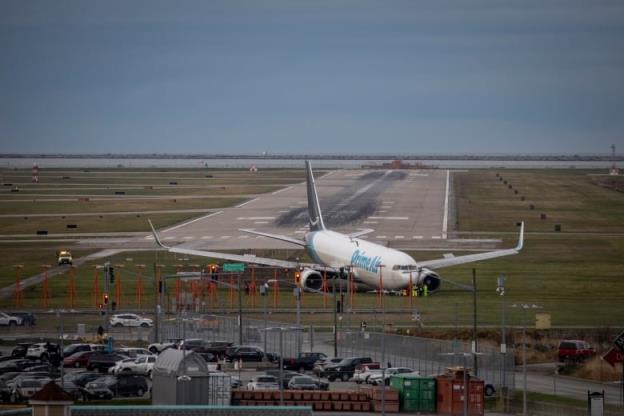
390;374;437;412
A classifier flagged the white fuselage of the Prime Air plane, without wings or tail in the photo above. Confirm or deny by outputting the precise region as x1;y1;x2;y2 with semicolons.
305;230;417;290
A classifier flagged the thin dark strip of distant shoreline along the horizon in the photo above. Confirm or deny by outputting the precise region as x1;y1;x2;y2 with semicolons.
0;153;624;162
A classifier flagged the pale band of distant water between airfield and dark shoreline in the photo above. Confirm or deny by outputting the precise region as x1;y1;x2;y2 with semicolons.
0;157;611;169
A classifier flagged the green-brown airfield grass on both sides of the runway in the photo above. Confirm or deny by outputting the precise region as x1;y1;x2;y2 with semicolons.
0;170;624;327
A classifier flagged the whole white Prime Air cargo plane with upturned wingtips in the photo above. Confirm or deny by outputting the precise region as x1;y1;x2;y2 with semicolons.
148;161;524;292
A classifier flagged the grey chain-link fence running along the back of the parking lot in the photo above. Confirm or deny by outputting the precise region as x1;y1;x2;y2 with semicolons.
161;316;515;391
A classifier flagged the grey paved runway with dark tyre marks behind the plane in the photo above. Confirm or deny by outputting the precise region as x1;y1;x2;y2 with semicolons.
145;170;450;250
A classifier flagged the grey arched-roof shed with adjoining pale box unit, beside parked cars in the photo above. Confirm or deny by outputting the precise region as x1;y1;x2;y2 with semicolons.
152;348;232;406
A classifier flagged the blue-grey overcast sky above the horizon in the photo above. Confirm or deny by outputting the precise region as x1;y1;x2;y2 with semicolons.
0;0;624;154
